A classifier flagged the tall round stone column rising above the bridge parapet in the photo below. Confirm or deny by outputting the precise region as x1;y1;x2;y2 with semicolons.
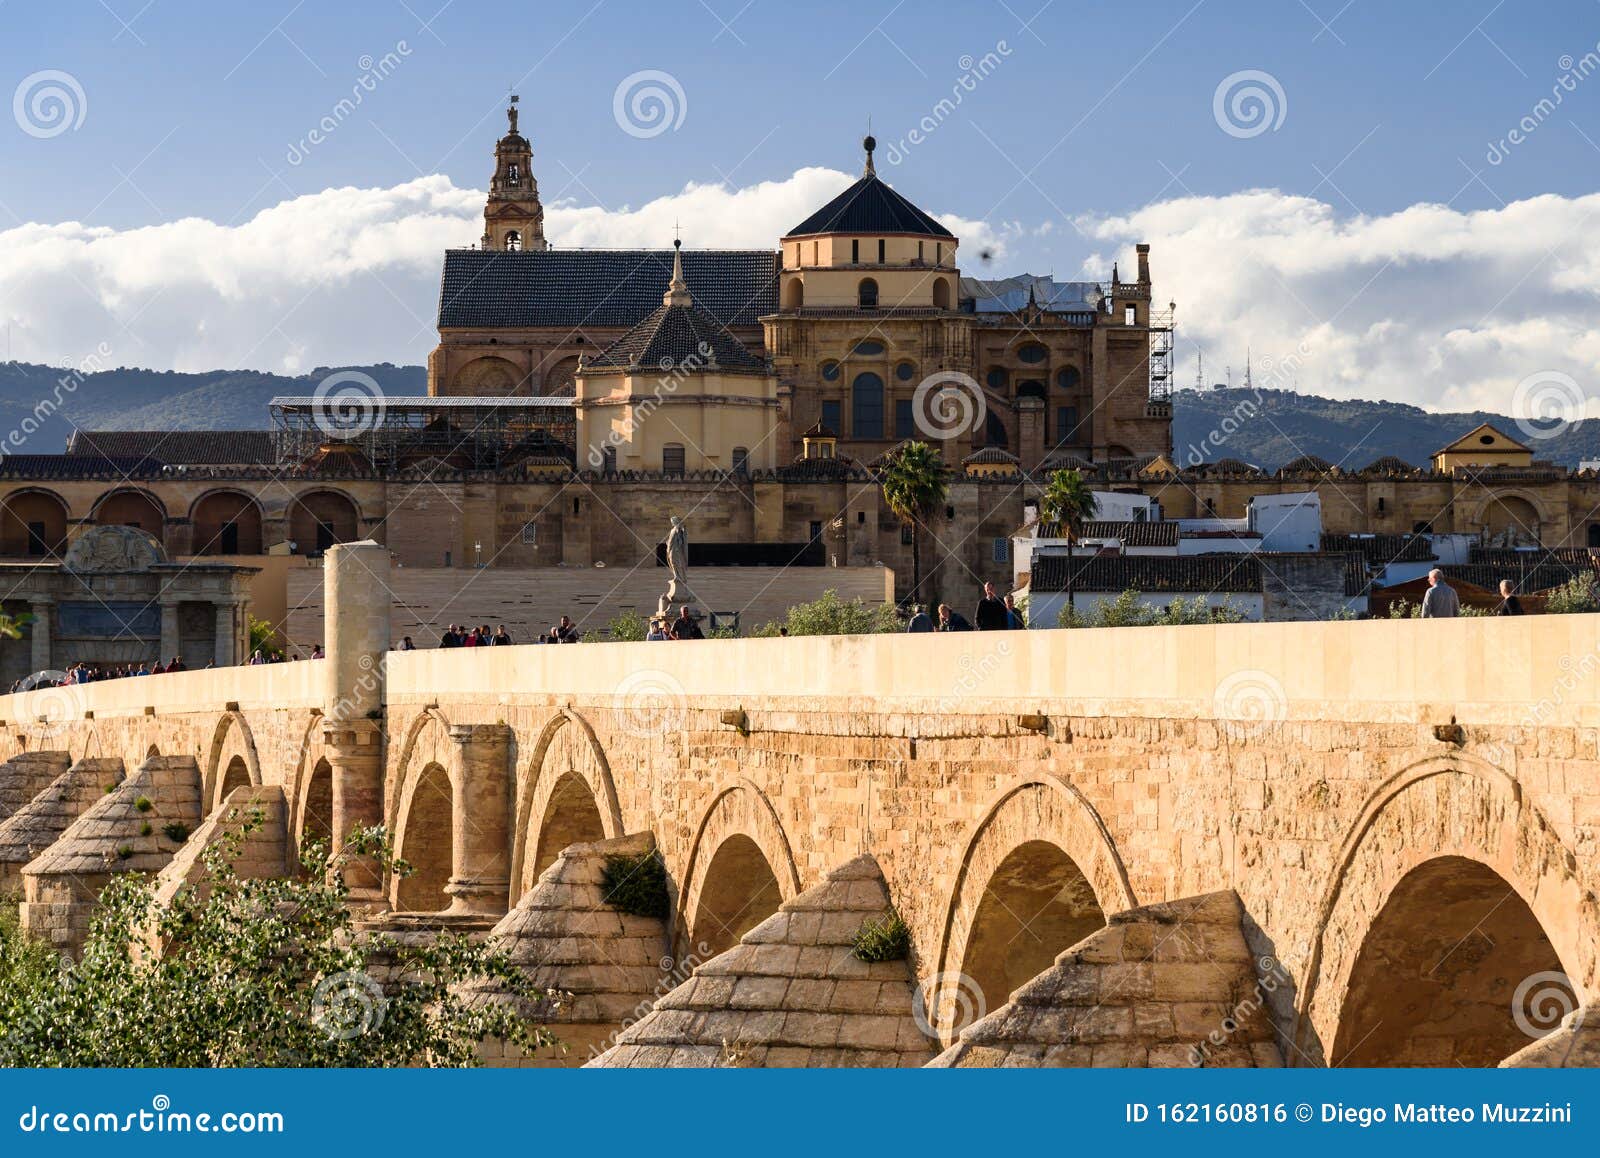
315;539;389;908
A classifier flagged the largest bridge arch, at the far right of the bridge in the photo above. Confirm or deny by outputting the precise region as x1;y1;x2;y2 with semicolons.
1291;757;1600;1065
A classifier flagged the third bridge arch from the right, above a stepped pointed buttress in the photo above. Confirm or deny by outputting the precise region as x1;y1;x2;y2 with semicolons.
677;777;800;960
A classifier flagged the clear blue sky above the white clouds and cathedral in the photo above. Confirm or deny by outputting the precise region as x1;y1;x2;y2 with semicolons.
0;0;1600;409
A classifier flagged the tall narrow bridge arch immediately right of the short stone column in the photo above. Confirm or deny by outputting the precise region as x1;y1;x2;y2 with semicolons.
510;709;624;904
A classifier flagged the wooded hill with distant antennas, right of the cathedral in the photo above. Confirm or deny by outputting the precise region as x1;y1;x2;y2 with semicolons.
1173;387;1600;470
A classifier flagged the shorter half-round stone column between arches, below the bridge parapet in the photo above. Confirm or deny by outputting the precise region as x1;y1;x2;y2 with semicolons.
445;723;510;916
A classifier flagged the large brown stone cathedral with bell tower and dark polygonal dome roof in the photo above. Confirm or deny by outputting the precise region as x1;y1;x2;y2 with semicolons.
429;107;1171;470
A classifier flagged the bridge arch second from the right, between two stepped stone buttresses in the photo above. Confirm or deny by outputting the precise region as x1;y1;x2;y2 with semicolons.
933;776;1138;1040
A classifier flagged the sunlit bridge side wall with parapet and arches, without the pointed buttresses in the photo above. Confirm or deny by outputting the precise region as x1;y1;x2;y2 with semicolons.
0;547;1600;1065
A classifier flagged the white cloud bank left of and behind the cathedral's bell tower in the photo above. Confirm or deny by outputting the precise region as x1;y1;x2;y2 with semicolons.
0;168;1011;371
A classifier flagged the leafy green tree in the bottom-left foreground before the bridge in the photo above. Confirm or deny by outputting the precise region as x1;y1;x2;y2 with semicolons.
0;811;554;1067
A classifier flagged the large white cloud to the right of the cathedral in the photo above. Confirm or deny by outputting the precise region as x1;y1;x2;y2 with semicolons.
1078;189;1600;411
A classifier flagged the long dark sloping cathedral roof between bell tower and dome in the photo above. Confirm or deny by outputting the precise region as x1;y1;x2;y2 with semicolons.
438;250;778;328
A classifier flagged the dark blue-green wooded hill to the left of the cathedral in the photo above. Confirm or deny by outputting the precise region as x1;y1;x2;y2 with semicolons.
0;361;427;454
